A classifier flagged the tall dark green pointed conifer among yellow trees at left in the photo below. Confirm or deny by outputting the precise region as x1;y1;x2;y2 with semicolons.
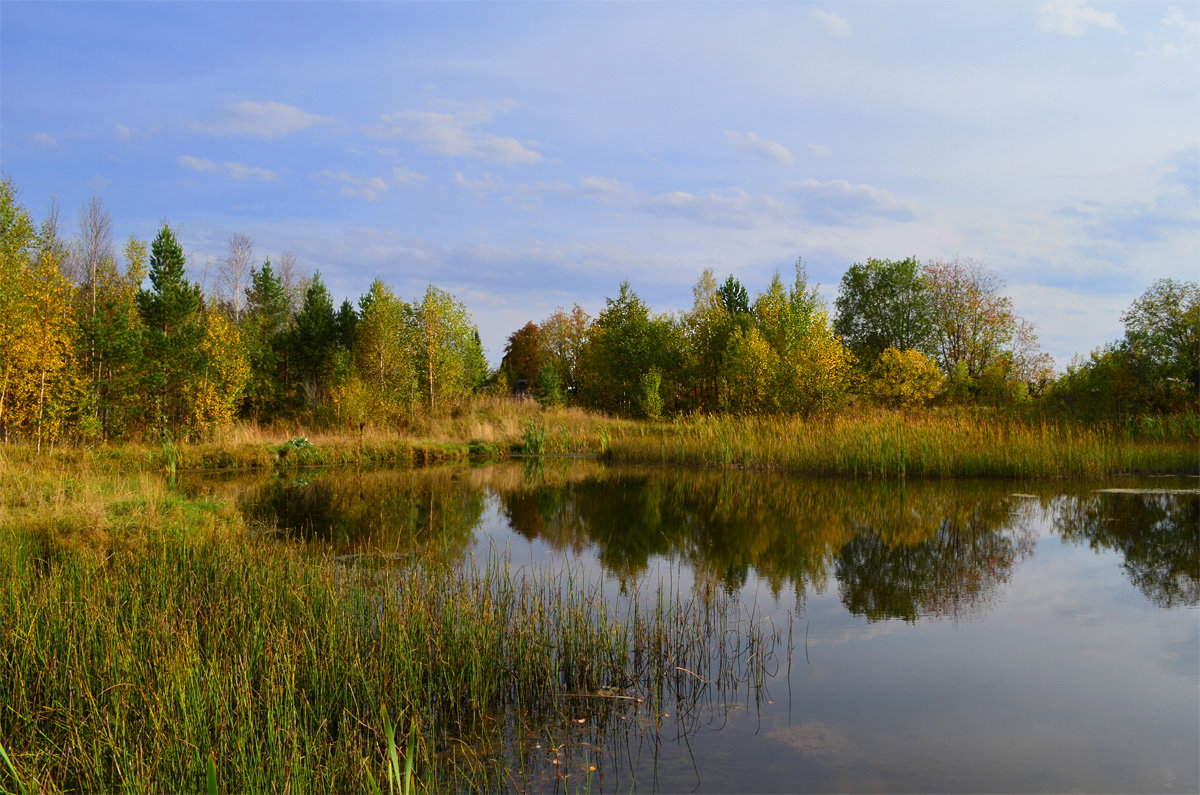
137;223;205;431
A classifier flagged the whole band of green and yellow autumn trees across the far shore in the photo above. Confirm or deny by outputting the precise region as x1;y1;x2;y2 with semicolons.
0;180;1200;449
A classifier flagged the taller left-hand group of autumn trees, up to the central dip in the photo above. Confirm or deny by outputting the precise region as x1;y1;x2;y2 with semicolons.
0;180;487;449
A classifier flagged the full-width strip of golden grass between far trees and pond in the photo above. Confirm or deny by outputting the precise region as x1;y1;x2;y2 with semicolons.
0;398;1200;478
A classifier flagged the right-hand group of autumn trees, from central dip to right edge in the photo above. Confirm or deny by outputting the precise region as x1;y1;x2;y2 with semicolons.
496;257;1200;420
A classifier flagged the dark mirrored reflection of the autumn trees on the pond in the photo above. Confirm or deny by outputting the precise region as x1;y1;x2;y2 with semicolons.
194;461;1200;621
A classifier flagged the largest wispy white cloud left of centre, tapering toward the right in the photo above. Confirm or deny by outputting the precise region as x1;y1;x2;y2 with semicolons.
367;110;541;166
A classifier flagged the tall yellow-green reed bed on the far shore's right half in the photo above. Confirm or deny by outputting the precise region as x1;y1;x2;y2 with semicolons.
607;412;1200;478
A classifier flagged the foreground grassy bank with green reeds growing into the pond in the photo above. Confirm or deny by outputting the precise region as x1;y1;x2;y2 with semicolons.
0;462;770;791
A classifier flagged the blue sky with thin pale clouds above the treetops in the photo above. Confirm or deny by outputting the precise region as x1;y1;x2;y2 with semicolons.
0;0;1200;367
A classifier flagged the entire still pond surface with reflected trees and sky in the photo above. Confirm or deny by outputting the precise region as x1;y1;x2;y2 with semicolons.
182;460;1200;793
